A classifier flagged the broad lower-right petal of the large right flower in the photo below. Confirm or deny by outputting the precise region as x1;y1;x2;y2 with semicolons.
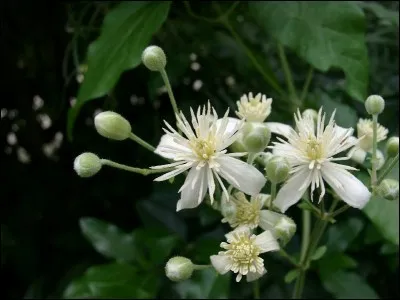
321;162;371;209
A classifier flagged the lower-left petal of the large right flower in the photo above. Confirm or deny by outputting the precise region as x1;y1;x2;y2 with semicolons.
273;166;312;213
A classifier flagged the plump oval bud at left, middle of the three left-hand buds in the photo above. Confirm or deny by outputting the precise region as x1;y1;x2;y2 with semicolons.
94;111;132;141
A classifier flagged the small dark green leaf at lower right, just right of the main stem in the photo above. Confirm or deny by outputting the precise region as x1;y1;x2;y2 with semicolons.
326;218;364;252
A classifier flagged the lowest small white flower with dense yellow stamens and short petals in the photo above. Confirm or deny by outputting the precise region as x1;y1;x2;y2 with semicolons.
210;227;279;282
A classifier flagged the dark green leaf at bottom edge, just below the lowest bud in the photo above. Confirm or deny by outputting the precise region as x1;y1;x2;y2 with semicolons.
174;268;230;299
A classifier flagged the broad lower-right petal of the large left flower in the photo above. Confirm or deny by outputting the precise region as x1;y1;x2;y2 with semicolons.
216;155;267;196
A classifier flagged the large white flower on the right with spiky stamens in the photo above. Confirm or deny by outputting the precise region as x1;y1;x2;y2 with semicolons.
271;109;371;212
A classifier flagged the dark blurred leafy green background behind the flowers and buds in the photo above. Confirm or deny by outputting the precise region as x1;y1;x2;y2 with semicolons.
0;1;400;299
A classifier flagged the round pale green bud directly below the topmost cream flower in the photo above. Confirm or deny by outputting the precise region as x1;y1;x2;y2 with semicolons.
242;122;271;153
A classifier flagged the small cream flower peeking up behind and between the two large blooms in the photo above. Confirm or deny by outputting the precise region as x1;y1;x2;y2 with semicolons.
231;93;291;136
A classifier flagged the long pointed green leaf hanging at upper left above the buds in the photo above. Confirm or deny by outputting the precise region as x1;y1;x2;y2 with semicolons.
67;1;170;139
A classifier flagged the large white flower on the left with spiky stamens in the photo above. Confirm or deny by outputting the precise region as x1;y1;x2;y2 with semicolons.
152;103;266;211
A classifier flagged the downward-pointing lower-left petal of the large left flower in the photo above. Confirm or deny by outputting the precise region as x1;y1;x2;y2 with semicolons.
176;167;207;211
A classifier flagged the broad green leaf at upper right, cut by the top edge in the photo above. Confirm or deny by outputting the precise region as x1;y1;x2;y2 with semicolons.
249;1;368;101
